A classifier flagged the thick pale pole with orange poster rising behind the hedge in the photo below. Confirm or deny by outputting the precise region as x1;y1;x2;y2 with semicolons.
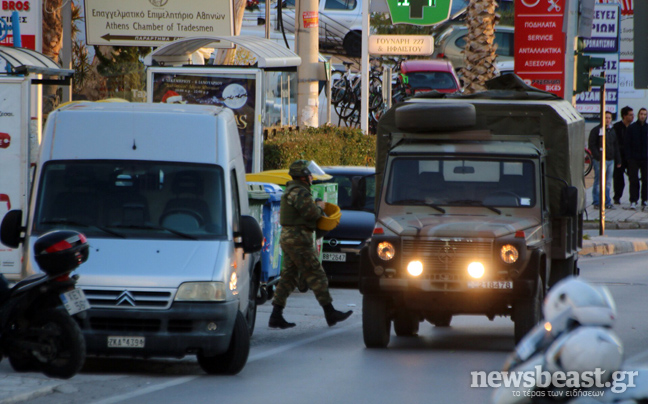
295;0;319;127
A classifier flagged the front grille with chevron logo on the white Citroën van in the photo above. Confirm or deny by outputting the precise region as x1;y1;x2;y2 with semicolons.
82;288;175;310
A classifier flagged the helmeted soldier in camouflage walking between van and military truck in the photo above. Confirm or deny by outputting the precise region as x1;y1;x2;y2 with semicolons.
268;160;353;329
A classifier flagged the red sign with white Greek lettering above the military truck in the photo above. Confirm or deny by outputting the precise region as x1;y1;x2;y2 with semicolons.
515;0;565;97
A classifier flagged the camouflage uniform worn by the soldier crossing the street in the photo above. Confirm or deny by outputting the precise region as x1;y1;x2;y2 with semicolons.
272;180;333;307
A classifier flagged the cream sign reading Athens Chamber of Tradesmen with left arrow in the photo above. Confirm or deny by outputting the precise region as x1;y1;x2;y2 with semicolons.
84;0;234;46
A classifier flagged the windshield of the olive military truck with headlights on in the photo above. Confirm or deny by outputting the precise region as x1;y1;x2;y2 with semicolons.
386;157;536;208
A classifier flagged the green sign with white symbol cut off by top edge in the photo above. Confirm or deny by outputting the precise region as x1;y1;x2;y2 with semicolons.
387;0;452;25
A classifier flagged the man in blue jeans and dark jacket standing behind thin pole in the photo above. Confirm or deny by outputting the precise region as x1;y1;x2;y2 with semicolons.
588;111;621;209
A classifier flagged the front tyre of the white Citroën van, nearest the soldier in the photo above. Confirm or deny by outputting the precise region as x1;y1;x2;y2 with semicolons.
197;311;250;375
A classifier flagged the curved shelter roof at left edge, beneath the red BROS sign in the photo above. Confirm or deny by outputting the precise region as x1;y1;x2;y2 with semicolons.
0;46;74;77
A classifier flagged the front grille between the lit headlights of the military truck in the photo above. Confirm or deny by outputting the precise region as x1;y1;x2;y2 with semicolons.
402;239;493;277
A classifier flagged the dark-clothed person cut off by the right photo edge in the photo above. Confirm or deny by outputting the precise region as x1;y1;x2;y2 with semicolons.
624;108;648;209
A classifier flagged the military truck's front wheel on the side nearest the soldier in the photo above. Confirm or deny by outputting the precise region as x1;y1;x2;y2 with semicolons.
362;295;391;348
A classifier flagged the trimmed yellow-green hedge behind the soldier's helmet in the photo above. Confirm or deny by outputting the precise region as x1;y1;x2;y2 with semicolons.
263;125;376;170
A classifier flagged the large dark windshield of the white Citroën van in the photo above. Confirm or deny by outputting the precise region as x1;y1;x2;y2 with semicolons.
33;160;227;239
